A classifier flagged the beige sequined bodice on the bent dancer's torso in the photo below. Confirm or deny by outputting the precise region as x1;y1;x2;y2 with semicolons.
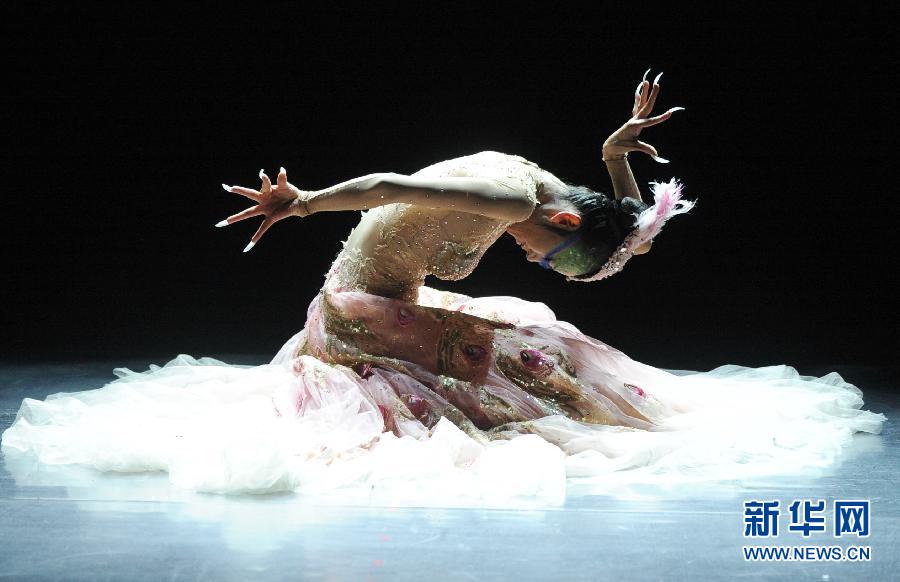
327;152;540;302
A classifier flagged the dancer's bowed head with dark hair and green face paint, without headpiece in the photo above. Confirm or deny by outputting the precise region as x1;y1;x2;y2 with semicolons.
508;184;649;277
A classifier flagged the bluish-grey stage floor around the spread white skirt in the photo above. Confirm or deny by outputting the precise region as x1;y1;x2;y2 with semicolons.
0;356;900;581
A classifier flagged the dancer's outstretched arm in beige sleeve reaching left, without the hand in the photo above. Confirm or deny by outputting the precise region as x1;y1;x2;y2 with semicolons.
307;173;534;222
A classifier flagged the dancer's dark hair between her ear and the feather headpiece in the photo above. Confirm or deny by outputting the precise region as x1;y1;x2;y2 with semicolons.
556;182;647;276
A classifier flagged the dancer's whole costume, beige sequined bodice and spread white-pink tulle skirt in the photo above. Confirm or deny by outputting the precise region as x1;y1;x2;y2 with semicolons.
3;152;885;502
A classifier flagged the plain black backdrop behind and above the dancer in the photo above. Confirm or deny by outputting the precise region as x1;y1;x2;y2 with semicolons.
0;2;897;371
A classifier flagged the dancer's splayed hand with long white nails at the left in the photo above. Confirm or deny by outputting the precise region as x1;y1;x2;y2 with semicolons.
216;168;310;253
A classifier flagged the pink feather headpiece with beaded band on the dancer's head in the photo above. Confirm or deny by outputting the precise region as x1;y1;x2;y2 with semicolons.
566;178;697;283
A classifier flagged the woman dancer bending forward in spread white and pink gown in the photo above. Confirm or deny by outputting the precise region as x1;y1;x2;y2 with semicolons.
3;70;884;491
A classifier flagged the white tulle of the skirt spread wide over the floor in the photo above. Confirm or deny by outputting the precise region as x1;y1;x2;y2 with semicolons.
2;297;885;499
